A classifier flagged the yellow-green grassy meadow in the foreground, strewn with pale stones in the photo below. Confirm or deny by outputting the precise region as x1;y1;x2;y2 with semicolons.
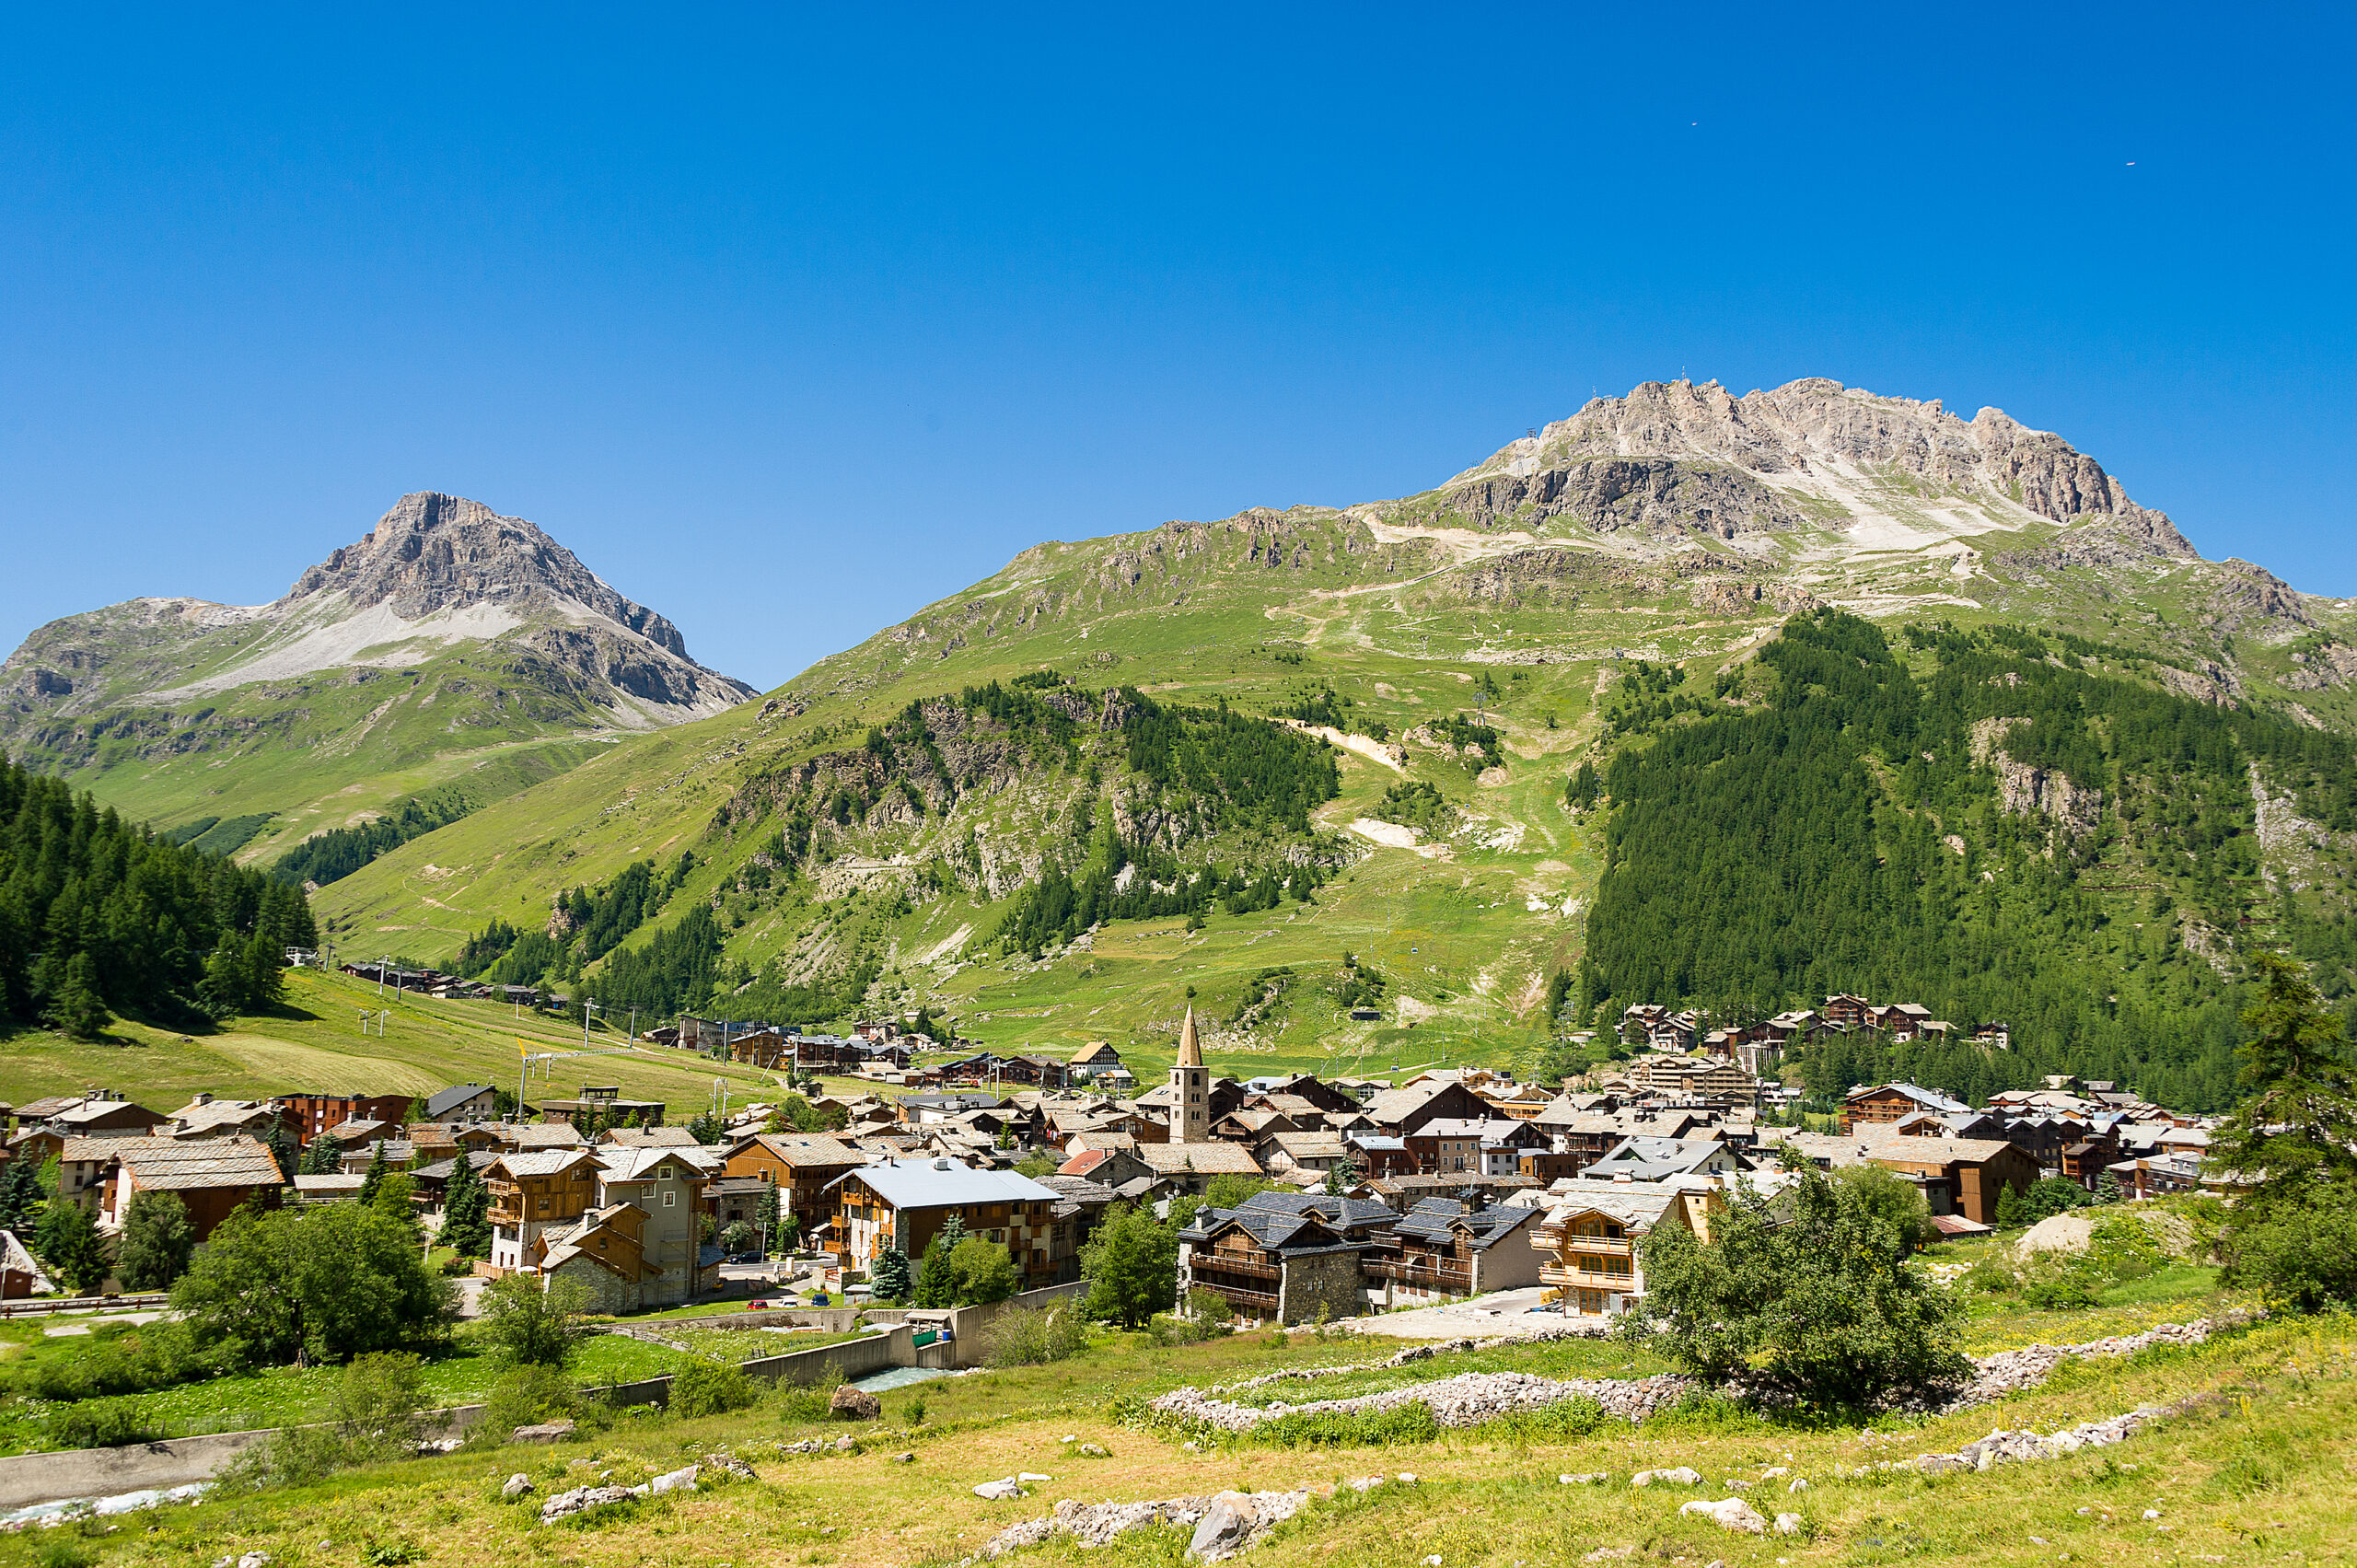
0;1254;2357;1568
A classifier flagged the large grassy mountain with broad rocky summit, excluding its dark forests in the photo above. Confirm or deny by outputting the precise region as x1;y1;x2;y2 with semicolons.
304;382;2357;1089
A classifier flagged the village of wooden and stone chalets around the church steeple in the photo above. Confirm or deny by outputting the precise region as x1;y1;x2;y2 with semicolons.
0;985;2213;1325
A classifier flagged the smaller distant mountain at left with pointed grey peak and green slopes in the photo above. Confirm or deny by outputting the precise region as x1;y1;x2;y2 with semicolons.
0;493;749;861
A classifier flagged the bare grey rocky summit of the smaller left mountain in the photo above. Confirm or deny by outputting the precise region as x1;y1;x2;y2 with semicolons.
271;491;689;657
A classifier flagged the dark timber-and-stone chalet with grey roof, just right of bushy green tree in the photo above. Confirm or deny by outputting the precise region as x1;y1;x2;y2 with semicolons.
1178;1193;1398;1323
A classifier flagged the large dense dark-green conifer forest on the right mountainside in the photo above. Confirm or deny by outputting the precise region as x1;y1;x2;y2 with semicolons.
1573;610;2357;1109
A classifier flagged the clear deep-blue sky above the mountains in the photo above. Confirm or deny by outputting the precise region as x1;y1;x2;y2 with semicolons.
0;5;2357;686
